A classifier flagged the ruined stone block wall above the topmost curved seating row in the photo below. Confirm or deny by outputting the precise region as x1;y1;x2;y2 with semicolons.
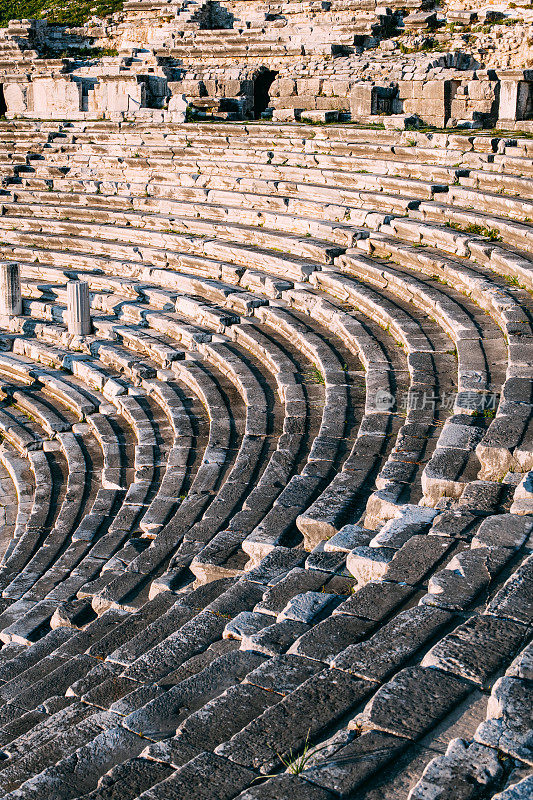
0;0;533;129
